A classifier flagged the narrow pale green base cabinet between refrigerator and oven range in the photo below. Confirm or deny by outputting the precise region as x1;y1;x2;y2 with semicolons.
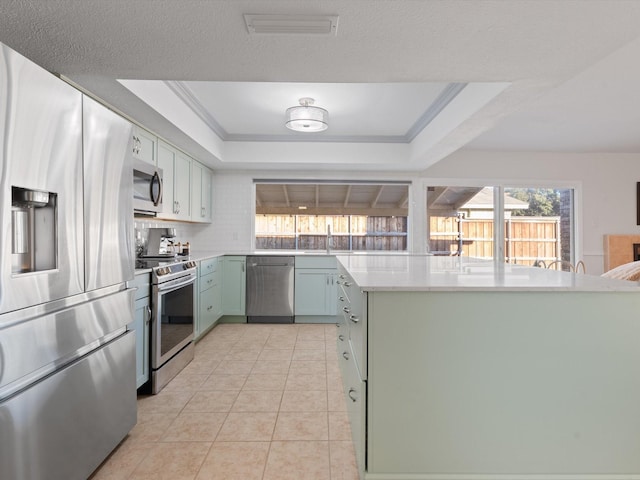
127;273;151;388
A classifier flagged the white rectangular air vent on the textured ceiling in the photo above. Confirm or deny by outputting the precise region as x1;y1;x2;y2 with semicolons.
244;14;338;35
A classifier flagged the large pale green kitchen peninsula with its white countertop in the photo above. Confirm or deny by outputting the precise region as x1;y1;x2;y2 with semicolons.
337;255;640;480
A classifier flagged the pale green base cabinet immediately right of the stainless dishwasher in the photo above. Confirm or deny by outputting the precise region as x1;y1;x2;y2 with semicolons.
294;255;338;323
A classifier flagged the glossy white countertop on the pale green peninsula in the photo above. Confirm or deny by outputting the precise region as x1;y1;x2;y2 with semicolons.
337;255;640;292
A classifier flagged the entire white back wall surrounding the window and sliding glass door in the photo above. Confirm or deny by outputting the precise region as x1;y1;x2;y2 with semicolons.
189;151;640;274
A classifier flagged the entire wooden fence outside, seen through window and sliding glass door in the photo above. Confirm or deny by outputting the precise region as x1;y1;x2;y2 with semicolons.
256;215;562;265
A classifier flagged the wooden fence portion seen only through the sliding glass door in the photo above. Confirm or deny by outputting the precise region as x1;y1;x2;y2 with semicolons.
429;216;562;265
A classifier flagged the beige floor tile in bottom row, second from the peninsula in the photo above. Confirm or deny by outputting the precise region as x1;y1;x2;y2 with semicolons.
263;441;331;480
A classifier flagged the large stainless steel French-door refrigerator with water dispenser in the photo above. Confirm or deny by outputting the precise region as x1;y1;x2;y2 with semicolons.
0;44;136;480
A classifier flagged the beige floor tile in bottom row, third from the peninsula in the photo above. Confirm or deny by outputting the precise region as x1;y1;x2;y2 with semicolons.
197;442;269;480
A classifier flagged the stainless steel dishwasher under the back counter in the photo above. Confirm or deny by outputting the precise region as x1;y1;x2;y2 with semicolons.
247;256;295;323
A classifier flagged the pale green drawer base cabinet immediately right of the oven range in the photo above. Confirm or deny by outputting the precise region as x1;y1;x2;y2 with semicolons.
195;257;222;340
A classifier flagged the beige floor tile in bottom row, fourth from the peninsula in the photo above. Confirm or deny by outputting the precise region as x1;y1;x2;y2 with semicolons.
131;442;211;480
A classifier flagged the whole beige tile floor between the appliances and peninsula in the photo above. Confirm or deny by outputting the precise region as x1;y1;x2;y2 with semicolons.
92;324;358;480
